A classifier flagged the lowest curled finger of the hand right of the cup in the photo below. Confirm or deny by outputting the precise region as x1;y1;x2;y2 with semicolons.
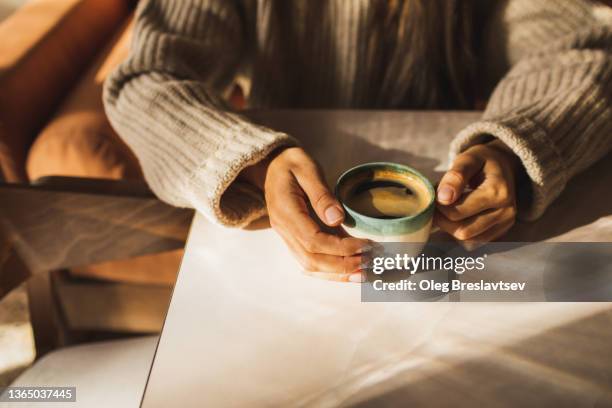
435;207;515;241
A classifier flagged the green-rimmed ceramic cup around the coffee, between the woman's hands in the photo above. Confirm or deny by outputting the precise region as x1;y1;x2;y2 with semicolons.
335;162;436;243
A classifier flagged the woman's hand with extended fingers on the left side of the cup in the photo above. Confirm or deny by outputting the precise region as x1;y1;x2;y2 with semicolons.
241;147;370;282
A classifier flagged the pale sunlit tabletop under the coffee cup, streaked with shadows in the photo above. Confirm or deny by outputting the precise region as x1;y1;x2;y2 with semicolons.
143;111;612;407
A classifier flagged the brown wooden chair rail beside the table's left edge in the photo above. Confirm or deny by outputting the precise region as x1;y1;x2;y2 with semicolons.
0;177;193;297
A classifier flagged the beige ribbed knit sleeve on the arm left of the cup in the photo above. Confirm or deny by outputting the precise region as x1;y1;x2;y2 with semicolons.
104;0;295;226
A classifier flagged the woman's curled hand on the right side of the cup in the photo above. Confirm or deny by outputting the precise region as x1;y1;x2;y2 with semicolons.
435;140;522;243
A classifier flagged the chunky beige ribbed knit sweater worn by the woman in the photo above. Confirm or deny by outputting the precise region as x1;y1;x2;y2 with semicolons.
104;0;612;226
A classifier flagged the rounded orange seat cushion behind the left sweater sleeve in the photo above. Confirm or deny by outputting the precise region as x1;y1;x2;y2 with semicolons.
27;17;142;180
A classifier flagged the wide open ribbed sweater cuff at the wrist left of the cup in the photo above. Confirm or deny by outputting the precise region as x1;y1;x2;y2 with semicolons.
189;124;297;227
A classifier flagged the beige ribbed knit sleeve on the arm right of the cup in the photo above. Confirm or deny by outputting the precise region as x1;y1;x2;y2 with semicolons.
451;0;612;220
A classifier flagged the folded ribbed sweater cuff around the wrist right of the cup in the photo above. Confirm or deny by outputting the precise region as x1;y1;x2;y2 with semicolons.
450;115;567;221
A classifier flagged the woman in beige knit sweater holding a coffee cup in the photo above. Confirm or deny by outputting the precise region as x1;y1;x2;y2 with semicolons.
104;0;612;281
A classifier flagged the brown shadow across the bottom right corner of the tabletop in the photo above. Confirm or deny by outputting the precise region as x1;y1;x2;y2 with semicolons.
343;308;612;408
